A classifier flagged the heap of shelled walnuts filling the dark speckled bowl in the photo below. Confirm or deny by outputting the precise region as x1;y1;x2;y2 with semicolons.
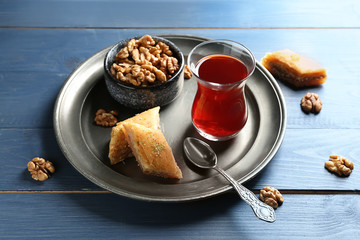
110;35;180;86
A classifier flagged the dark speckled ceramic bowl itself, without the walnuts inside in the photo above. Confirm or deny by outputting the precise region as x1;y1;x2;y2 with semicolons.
104;36;184;109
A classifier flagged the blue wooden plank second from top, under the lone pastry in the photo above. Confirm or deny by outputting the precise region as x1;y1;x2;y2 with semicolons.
0;29;360;129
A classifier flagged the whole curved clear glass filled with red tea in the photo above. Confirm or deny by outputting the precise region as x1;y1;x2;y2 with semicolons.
187;39;256;141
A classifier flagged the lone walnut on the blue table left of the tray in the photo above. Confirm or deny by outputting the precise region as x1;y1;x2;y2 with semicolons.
27;157;55;181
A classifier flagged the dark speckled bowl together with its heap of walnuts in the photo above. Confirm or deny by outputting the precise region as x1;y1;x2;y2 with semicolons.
104;35;184;109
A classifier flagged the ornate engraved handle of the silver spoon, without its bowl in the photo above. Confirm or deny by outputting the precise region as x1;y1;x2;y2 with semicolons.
214;166;276;222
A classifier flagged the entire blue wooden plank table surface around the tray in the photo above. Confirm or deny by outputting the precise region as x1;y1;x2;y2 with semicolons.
0;0;360;239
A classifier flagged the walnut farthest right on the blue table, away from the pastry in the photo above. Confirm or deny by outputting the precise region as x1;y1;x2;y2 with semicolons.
325;155;354;176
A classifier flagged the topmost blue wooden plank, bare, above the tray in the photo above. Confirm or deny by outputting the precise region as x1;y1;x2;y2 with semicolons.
0;0;360;28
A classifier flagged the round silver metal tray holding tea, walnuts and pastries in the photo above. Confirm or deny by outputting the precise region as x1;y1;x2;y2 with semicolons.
54;35;286;201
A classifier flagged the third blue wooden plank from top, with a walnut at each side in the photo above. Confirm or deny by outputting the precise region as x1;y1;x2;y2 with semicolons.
0;129;360;192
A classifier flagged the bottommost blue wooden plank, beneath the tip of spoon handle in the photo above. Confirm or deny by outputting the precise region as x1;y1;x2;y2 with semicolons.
0;194;360;240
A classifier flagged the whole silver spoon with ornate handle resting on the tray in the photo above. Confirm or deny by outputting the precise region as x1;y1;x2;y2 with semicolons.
184;137;276;222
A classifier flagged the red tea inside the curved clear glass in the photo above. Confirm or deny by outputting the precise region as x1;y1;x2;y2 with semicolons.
192;55;248;138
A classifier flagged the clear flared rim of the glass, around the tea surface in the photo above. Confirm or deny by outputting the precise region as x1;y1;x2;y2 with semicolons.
187;39;256;87
